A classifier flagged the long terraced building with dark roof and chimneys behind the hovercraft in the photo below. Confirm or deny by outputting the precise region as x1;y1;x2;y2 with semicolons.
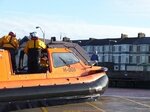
73;33;150;72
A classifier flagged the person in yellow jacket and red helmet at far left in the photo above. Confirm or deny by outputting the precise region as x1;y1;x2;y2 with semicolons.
0;31;19;72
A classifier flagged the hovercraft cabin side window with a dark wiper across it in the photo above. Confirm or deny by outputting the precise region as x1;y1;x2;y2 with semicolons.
52;53;79;67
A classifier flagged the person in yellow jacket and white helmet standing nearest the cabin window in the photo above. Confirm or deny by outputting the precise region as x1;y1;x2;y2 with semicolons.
24;32;46;73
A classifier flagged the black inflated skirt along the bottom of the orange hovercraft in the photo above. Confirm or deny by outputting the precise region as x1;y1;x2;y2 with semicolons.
0;75;108;102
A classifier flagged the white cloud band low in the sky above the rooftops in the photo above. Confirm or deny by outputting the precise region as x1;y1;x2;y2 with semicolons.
0;16;150;39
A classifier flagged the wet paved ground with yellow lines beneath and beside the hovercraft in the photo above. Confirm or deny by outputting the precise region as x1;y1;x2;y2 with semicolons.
12;88;150;112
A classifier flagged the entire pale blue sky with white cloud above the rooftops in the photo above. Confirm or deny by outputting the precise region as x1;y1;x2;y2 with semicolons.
0;0;150;39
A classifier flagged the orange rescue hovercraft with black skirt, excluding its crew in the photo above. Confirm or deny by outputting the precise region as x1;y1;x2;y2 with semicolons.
0;42;108;102
